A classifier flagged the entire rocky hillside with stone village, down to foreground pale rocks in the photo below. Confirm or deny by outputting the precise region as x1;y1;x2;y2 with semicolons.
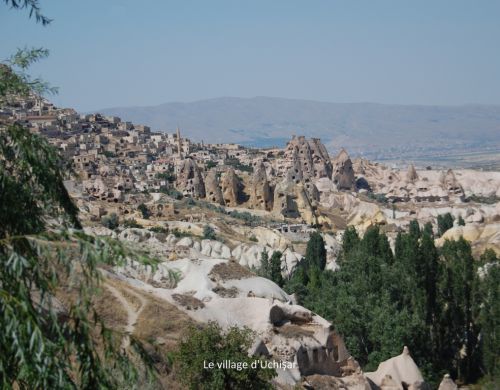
0;97;500;389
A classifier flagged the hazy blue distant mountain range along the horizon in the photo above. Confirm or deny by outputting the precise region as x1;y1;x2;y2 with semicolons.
97;97;500;161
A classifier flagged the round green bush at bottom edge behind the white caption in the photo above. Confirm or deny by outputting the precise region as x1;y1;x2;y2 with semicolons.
173;322;276;390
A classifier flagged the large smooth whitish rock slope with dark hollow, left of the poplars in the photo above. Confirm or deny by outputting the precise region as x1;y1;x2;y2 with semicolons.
115;259;360;385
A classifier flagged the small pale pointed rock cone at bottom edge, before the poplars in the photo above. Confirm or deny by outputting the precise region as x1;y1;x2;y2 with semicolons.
365;346;429;390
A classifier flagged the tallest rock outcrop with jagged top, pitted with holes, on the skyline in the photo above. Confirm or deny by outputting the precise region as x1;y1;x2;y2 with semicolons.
281;136;332;178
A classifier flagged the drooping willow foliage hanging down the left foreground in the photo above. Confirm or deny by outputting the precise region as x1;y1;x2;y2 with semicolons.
0;125;160;389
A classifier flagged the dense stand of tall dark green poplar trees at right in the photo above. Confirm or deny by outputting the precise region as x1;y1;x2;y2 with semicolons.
285;222;500;384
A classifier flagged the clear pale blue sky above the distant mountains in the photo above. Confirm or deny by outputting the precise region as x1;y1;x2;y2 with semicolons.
0;0;500;110
